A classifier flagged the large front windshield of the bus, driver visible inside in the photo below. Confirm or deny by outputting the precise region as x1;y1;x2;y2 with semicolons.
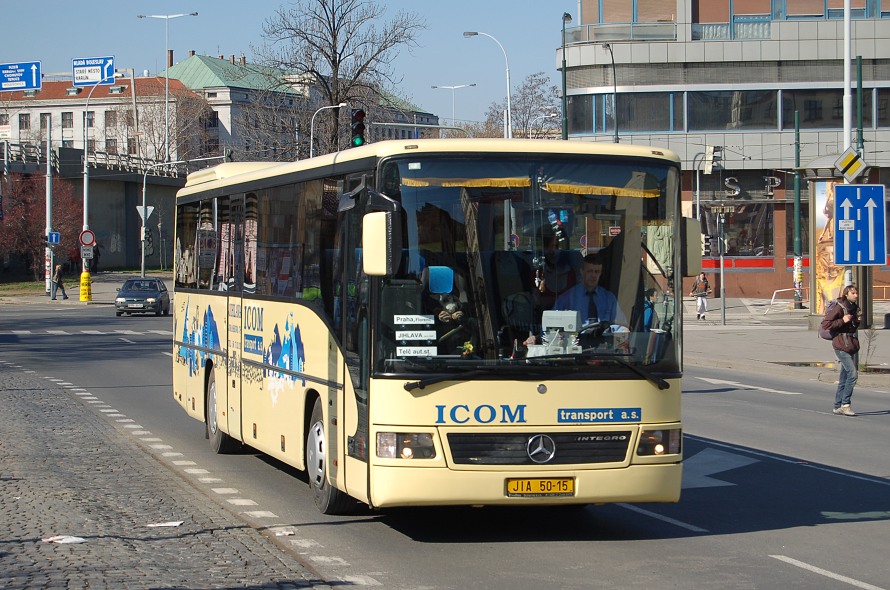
374;154;680;378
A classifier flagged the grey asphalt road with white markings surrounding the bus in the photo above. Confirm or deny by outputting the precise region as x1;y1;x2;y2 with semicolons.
0;302;890;590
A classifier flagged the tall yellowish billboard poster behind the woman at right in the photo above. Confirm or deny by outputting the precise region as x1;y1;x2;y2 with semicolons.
810;180;844;315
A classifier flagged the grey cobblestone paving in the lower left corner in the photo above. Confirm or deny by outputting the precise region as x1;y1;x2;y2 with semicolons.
0;363;328;590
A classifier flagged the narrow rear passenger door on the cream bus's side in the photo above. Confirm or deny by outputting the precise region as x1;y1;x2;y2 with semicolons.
220;195;246;440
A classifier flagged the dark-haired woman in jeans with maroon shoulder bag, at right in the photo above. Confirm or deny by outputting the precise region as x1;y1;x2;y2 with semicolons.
822;285;860;416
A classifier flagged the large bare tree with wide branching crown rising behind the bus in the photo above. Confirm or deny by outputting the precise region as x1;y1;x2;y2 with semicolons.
255;0;426;153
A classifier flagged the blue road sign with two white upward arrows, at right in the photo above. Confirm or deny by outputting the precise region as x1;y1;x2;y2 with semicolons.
834;184;887;266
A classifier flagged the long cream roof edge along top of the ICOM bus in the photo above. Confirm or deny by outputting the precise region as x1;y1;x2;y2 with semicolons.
177;138;680;197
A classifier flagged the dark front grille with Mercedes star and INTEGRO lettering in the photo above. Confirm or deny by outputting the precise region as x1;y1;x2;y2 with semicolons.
448;430;632;465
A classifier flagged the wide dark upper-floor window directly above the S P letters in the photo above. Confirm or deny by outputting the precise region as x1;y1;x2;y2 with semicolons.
687;90;778;131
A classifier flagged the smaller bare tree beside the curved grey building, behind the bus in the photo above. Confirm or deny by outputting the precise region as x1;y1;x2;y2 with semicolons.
474;72;562;138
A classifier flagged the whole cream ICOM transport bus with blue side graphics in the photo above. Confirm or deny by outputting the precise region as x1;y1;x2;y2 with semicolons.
173;139;701;513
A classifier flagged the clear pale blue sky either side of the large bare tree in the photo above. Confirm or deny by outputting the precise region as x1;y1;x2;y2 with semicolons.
0;0;579;121
